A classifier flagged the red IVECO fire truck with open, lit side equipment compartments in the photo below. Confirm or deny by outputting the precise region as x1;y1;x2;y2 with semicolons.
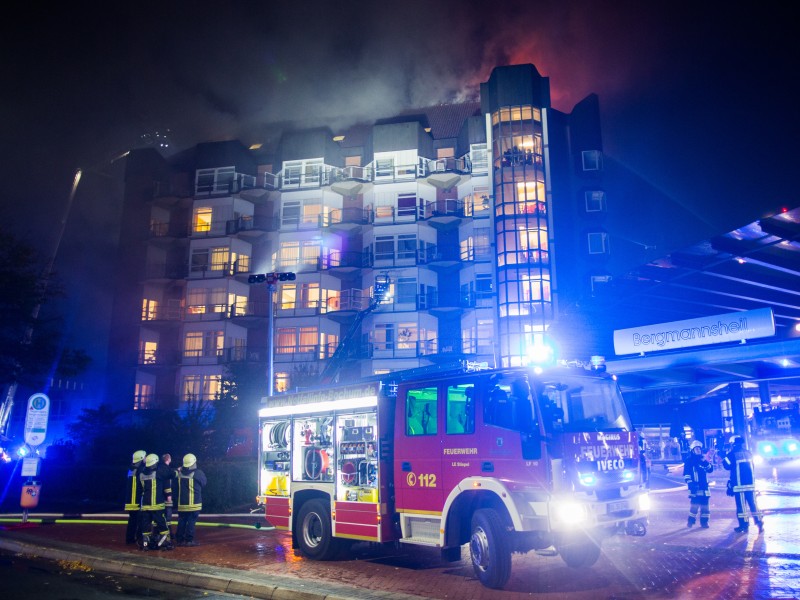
258;358;649;588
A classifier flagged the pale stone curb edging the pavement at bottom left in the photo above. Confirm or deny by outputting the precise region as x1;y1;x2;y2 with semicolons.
0;531;422;600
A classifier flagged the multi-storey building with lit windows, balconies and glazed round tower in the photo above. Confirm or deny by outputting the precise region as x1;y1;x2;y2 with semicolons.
104;65;632;408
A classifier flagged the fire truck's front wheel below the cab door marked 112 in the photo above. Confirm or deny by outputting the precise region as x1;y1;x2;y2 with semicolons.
469;508;511;590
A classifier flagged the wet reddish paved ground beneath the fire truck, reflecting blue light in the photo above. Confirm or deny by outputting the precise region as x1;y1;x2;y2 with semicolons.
0;473;800;600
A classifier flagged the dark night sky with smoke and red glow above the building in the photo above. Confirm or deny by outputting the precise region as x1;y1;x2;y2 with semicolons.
0;0;800;392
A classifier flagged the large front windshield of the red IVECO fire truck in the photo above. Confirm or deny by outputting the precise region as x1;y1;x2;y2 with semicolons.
536;376;632;433
